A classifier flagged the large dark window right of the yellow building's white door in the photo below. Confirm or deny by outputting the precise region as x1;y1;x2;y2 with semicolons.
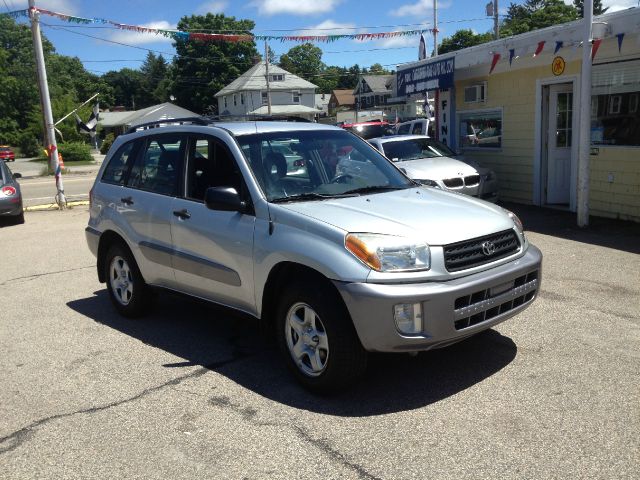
591;60;640;146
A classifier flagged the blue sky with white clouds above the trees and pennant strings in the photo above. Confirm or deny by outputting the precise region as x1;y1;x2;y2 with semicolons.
6;0;638;74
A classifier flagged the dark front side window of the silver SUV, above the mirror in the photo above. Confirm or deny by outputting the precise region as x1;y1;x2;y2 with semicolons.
186;137;243;201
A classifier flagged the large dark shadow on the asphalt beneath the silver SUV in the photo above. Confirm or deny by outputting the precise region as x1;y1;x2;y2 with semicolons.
67;290;517;417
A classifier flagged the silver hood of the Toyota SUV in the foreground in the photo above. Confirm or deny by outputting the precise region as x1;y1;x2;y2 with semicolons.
278;187;514;245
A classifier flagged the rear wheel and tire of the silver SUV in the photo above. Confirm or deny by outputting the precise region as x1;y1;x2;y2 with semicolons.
104;243;151;318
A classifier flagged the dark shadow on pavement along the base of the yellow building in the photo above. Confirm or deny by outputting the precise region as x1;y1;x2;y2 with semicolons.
501;203;640;253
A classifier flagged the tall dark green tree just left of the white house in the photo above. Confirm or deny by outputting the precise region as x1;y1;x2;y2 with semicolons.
170;13;260;113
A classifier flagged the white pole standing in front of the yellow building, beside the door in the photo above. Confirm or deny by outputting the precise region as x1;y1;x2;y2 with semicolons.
577;0;593;227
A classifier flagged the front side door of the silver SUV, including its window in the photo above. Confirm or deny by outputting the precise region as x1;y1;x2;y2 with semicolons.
171;134;255;313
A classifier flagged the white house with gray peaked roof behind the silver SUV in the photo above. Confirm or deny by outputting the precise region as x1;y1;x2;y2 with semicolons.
215;62;321;120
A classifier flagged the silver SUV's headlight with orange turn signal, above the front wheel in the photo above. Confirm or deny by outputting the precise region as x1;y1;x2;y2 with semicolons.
344;233;431;272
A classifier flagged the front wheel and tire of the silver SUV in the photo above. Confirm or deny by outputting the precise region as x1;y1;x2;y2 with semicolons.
275;277;367;393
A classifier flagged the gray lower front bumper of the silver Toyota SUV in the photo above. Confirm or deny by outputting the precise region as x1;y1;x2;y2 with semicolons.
334;245;542;352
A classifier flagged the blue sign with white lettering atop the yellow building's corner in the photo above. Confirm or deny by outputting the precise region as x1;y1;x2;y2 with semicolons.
396;57;455;97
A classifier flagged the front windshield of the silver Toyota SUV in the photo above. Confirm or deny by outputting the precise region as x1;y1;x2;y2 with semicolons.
237;130;413;202
